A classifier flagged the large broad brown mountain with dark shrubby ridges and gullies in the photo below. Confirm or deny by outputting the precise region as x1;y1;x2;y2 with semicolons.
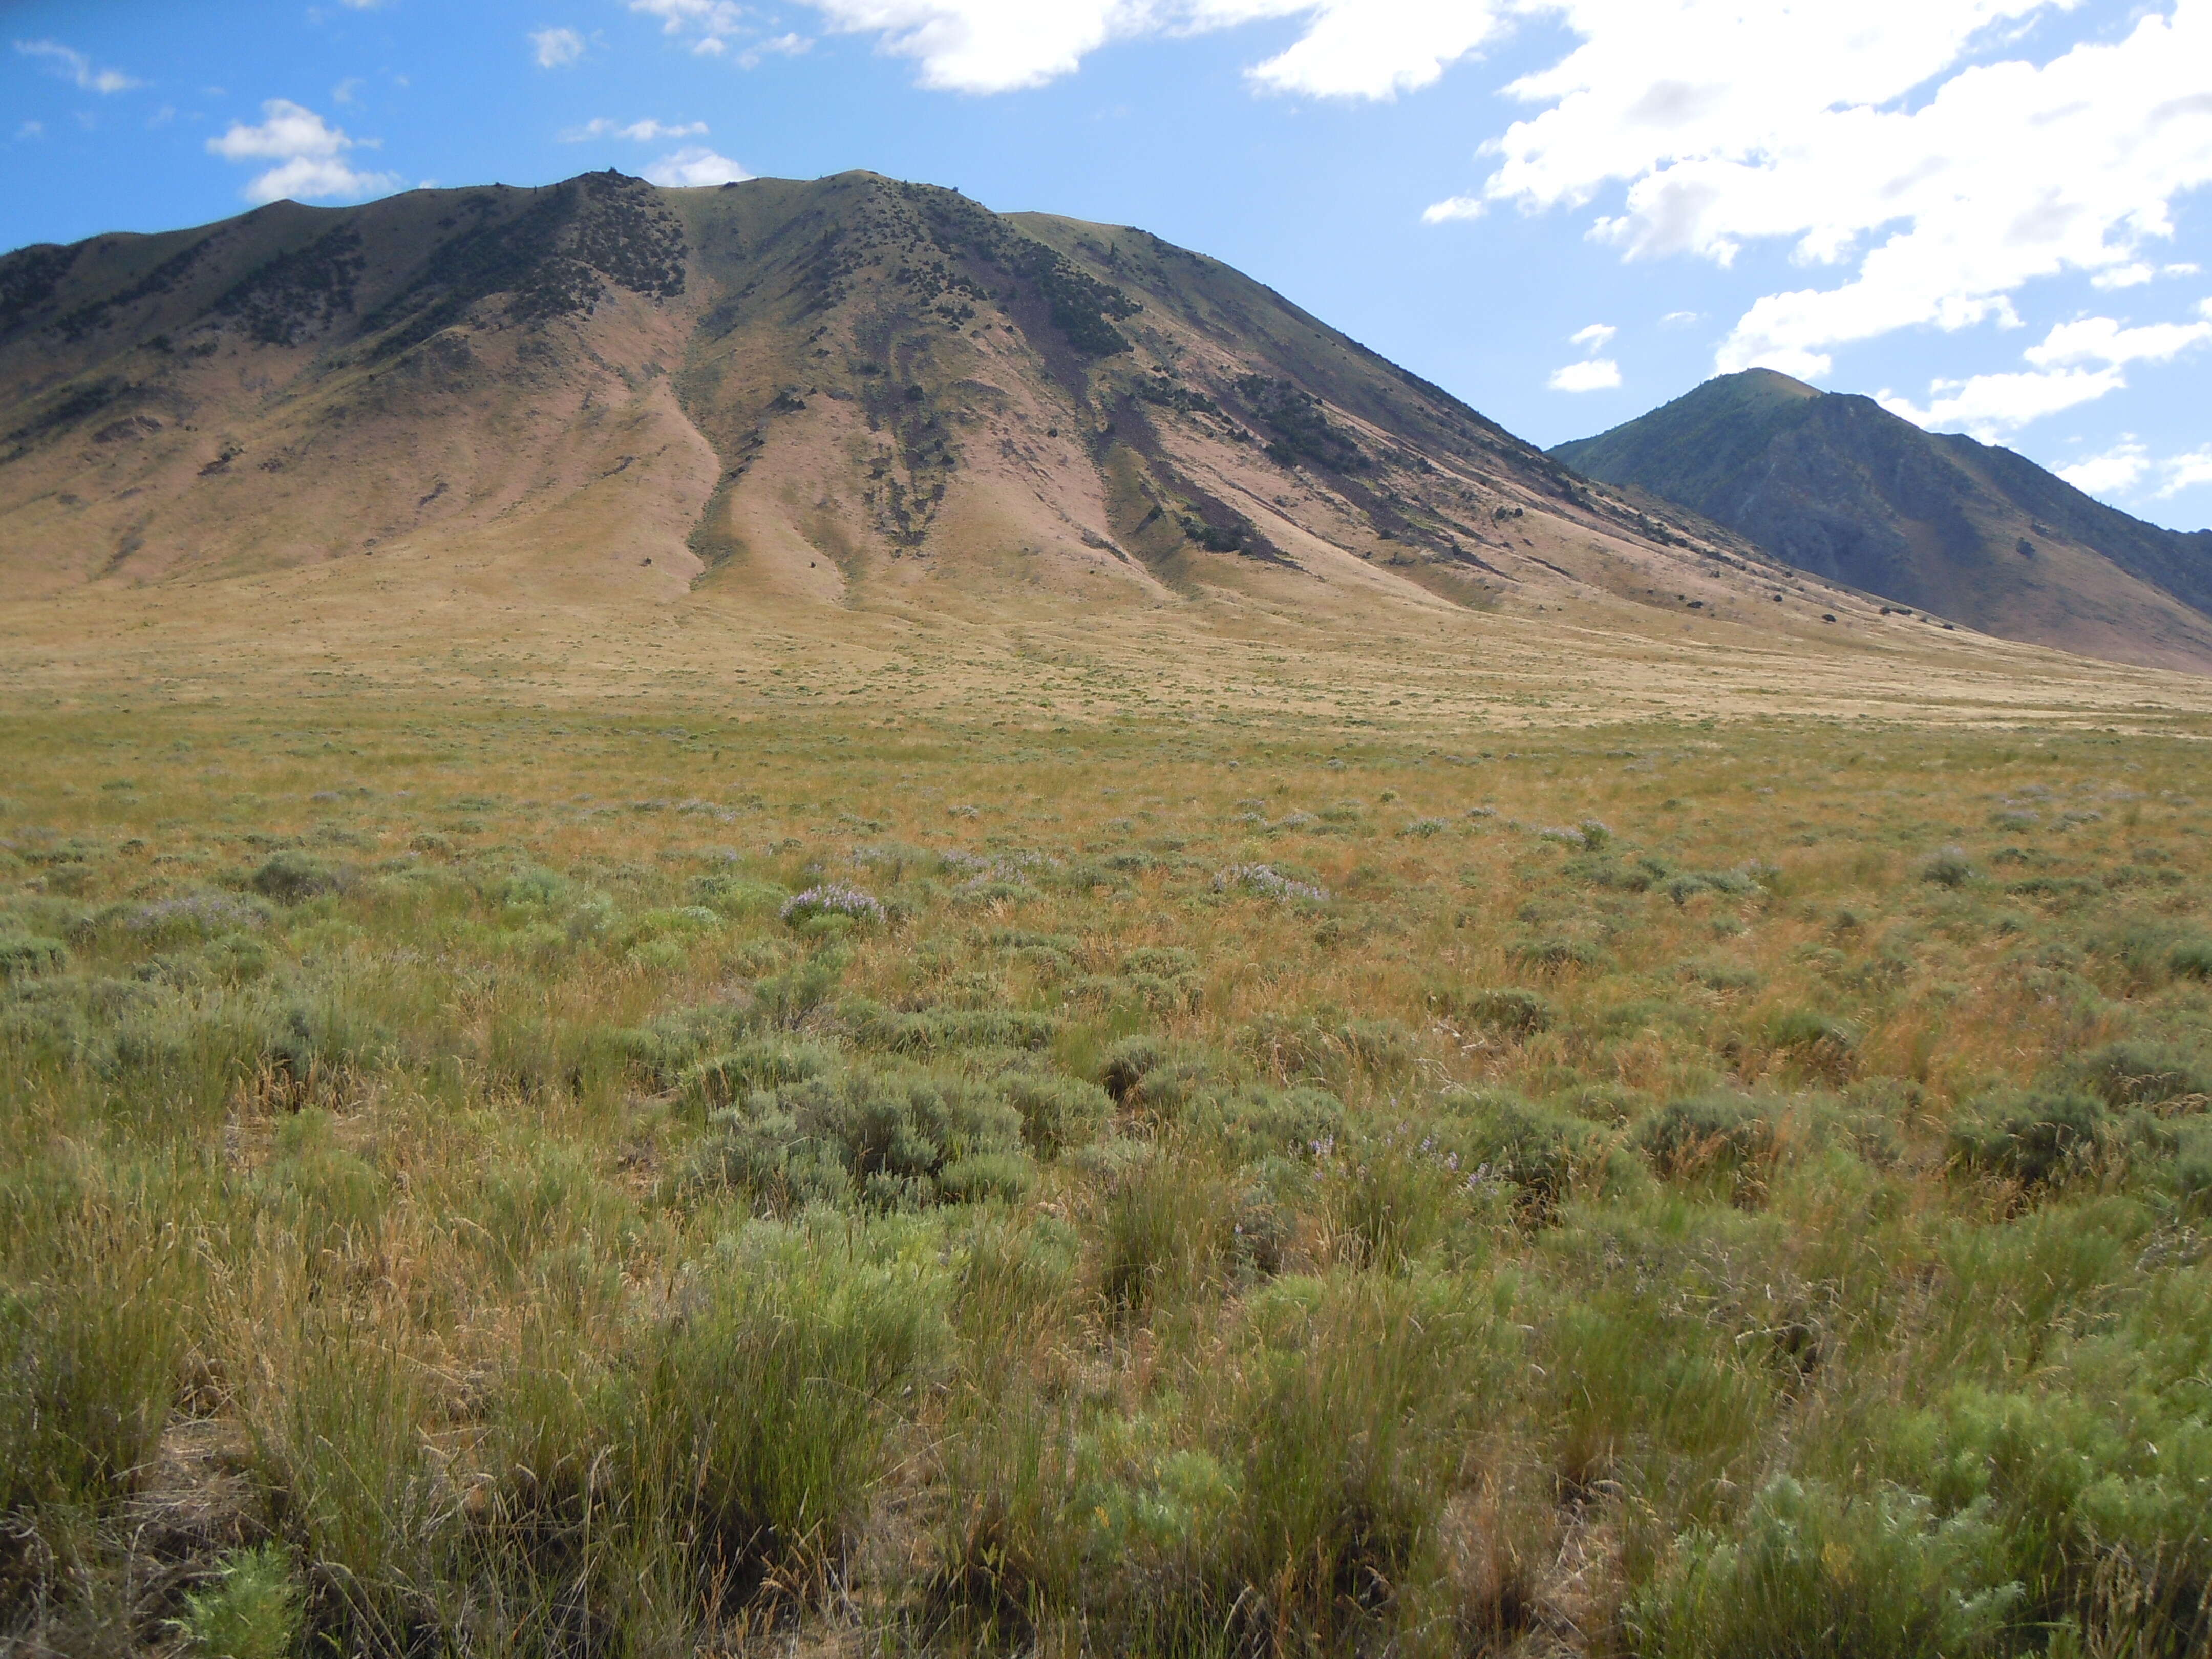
0;162;1871;633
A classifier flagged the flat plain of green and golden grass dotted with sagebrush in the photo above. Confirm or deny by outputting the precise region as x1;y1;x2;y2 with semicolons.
0;681;2212;1657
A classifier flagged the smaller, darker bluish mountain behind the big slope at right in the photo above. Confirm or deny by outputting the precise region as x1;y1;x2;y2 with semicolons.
1550;369;2212;672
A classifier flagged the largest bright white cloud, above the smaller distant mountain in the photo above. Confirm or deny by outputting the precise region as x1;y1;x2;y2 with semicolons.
1433;0;2212;374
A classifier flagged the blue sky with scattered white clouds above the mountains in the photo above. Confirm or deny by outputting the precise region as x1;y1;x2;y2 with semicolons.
0;0;2212;528
